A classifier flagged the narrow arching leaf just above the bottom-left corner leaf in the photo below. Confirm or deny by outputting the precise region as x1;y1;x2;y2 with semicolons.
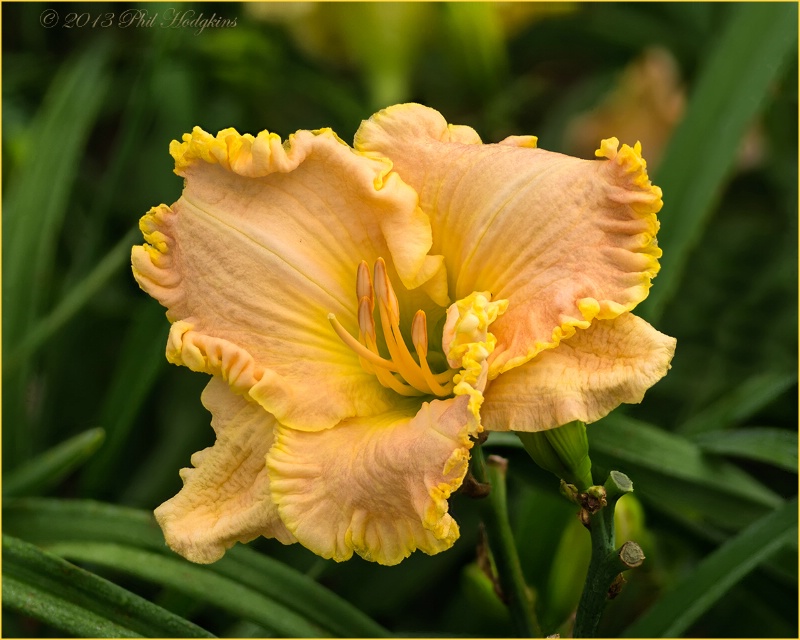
47;542;321;638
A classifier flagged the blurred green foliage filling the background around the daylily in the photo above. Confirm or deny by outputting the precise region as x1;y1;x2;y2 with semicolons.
2;2;798;637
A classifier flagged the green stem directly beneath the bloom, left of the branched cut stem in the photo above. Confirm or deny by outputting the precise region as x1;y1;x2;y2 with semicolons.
472;447;543;638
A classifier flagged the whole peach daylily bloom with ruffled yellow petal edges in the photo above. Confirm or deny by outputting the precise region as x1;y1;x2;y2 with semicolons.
133;104;675;565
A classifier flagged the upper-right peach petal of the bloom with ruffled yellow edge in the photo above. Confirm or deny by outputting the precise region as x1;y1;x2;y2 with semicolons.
356;104;662;379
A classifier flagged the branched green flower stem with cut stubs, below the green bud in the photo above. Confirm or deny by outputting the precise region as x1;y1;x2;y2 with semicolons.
573;471;644;638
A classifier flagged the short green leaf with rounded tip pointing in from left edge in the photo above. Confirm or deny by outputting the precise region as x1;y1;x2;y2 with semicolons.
3;428;105;498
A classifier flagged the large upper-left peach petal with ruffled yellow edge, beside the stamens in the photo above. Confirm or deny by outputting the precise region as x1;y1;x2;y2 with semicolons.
132;129;447;429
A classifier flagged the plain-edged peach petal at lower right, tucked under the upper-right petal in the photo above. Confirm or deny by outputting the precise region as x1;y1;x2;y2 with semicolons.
481;313;675;431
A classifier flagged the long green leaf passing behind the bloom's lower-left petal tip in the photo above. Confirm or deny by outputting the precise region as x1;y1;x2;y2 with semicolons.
3;499;389;637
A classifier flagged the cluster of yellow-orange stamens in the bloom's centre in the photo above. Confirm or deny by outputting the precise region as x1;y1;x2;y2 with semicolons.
328;258;456;397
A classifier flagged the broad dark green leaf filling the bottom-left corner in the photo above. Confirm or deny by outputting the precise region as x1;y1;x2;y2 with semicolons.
3;535;213;638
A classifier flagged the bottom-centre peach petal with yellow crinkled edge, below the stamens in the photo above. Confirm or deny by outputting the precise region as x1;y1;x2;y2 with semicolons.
267;396;472;565
